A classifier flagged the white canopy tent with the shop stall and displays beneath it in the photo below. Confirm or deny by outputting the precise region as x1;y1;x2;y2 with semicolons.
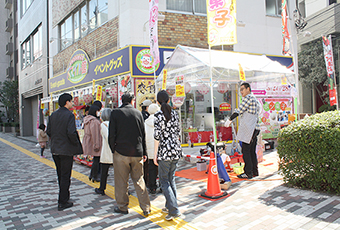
156;46;296;144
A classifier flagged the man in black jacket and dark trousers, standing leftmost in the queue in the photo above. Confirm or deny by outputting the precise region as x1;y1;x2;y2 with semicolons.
46;93;83;211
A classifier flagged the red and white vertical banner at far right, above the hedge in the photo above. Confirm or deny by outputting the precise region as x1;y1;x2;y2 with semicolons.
322;35;338;106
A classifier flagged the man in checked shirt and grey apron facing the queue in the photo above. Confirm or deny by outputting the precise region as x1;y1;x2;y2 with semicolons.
225;82;260;179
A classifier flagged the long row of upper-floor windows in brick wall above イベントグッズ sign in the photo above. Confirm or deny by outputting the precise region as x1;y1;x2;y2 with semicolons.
59;0;108;49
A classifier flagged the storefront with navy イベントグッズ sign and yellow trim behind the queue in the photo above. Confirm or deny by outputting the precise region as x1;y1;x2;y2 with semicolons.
40;45;174;164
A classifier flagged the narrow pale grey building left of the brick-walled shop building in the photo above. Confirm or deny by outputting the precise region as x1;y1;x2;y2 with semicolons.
17;0;51;136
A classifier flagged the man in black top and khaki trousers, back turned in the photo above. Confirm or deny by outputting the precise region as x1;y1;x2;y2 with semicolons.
109;92;150;216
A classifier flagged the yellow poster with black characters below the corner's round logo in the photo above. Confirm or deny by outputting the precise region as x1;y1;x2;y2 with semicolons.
135;79;156;110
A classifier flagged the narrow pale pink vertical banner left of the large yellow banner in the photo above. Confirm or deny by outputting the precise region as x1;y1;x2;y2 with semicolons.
149;0;160;66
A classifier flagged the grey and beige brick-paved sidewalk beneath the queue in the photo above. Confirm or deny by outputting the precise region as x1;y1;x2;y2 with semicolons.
0;133;340;229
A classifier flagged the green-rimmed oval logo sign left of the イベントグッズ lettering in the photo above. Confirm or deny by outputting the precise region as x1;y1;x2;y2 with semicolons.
66;50;90;83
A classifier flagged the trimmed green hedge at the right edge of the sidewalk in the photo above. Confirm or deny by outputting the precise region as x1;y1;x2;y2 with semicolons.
277;111;340;194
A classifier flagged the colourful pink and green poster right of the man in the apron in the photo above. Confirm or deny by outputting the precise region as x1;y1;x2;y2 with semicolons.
258;98;293;139
